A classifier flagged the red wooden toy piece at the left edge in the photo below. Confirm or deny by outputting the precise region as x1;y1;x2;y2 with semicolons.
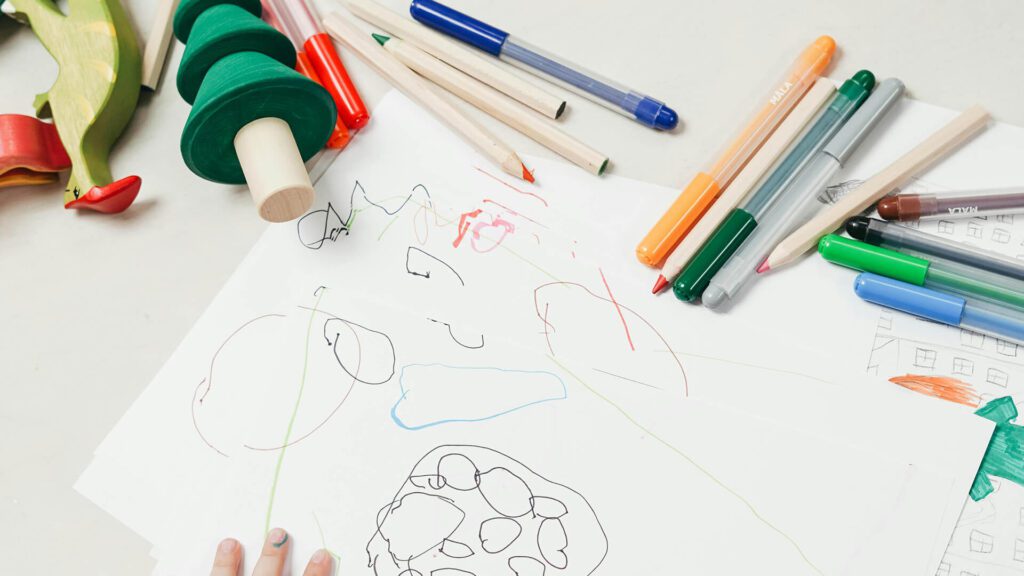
0;114;71;188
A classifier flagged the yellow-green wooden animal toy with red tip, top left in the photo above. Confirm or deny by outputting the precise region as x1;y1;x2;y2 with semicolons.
4;0;142;213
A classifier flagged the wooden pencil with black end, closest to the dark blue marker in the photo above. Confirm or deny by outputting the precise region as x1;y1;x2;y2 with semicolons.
345;0;565;119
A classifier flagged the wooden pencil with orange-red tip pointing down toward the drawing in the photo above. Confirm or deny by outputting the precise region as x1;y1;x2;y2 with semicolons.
324;11;534;182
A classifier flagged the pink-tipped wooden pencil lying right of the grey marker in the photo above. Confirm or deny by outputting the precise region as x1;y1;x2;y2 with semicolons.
764;106;989;272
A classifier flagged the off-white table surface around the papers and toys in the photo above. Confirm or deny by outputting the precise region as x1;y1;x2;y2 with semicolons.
0;0;1024;576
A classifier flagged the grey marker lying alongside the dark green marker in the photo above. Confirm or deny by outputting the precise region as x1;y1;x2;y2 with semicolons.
701;78;903;308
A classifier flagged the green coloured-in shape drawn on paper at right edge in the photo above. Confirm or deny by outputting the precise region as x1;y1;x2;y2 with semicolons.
971;396;1024;501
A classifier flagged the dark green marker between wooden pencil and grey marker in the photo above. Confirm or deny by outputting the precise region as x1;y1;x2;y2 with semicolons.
672;70;874;302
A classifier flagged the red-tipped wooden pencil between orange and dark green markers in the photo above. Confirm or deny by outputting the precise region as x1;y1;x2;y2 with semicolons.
651;78;836;294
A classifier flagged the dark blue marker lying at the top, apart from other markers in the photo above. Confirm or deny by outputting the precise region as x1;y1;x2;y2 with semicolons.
409;0;679;130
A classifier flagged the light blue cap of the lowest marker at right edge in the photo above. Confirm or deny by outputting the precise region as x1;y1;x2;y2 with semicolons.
853;272;967;326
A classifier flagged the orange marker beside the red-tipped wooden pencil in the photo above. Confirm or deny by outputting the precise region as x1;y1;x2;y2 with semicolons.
637;36;836;266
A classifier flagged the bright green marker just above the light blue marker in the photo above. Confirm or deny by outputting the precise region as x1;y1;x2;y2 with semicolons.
818;234;1024;310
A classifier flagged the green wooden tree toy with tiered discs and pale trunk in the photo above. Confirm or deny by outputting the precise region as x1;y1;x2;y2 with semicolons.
174;0;338;222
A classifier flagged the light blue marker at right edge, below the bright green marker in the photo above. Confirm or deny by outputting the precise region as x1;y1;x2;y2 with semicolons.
853;272;1024;343
